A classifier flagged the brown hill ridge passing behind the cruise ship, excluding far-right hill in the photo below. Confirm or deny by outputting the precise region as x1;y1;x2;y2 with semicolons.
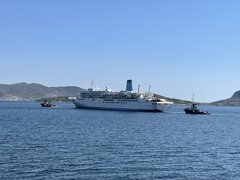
0;82;190;104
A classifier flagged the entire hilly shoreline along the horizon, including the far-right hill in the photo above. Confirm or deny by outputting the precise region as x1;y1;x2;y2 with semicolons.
0;83;240;106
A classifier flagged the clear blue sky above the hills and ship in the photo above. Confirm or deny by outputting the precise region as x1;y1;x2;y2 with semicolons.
0;0;240;102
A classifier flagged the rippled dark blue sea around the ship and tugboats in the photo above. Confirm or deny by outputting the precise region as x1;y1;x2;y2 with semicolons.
0;102;240;180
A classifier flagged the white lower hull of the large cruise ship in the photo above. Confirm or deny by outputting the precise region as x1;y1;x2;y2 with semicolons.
73;99;169;112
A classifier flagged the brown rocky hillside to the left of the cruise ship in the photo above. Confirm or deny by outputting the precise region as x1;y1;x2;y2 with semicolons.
0;83;81;100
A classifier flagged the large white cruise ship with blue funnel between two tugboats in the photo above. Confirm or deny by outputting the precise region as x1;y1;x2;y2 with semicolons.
73;80;173;112
